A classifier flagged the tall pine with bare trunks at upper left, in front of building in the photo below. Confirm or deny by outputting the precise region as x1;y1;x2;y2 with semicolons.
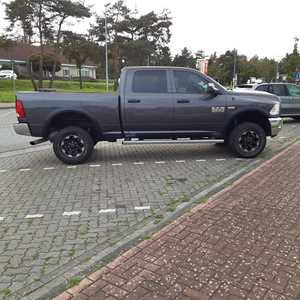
5;0;90;89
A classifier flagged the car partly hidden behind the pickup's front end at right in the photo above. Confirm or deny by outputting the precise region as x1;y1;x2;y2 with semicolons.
254;83;300;120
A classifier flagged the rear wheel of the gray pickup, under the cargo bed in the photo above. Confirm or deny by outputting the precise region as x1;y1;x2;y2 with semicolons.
53;126;94;165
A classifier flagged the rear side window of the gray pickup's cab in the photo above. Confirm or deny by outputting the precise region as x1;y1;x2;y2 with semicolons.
132;70;168;94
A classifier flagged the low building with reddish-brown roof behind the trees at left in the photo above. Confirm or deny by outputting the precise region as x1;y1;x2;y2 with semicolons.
0;43;97;80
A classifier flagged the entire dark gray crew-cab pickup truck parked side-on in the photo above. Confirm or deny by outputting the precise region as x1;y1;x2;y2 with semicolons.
14;67;282;164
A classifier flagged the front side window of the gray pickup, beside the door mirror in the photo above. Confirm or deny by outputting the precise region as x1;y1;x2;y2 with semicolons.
174;71;208;94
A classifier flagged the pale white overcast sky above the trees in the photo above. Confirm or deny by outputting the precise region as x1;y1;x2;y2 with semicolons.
0;0;300;59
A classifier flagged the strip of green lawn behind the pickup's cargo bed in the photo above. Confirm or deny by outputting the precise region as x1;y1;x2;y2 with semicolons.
0;80;113;102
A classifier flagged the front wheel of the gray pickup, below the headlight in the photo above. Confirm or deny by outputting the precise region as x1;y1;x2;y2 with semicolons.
229;122;267;158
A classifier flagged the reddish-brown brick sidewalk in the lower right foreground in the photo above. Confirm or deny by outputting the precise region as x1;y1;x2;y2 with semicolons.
56;143;300;300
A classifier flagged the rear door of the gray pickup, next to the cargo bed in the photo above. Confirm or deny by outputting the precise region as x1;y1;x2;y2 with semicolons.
123;69;174;138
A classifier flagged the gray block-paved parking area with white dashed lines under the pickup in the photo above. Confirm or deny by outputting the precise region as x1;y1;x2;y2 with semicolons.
0;110;300;299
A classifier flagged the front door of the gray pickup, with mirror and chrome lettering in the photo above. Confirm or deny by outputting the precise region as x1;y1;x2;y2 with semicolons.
172;70;226;136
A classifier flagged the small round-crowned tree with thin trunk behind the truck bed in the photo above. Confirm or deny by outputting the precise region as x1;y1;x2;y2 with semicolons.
62;31;98;89
